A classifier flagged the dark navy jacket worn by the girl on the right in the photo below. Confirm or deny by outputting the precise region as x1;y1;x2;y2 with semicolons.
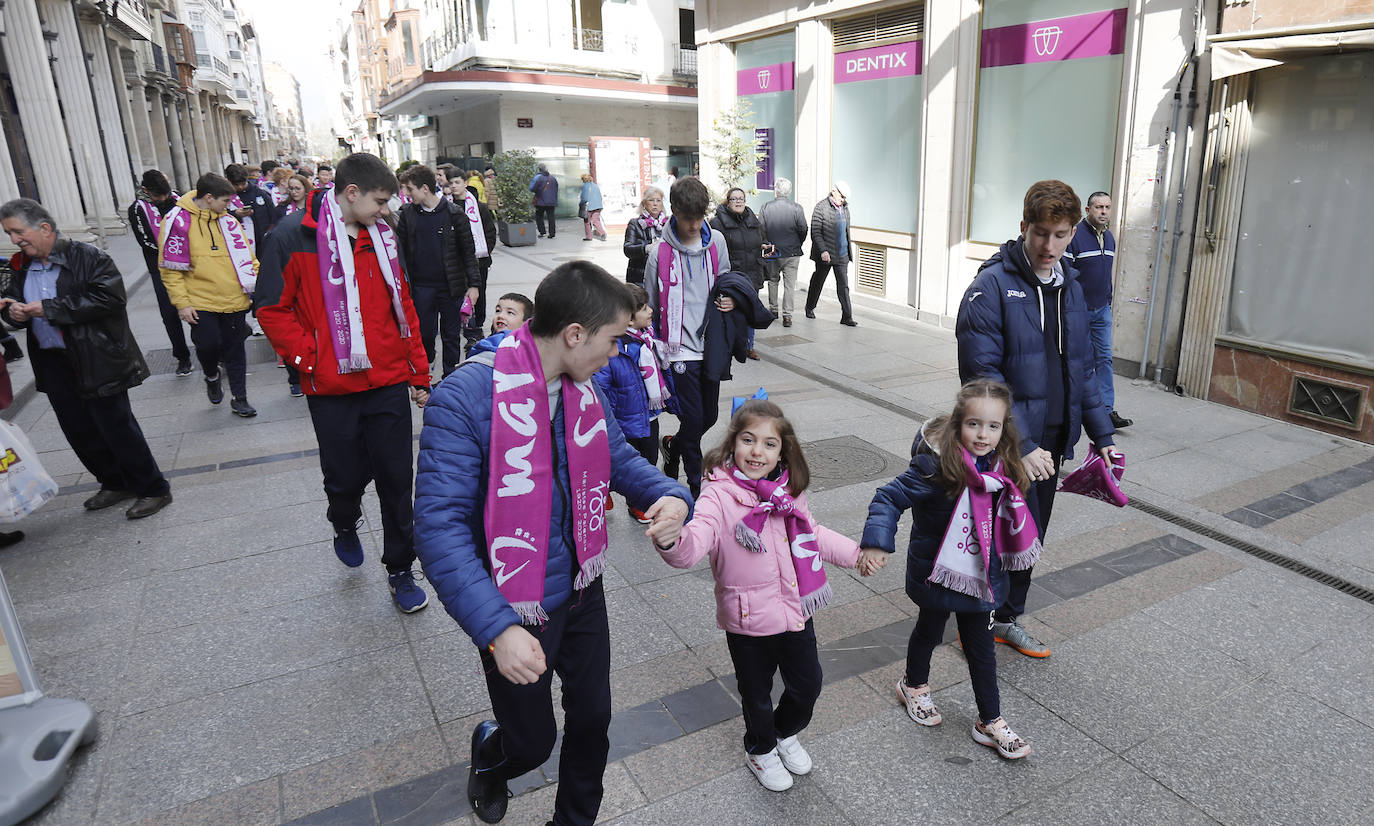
862;422;1009;612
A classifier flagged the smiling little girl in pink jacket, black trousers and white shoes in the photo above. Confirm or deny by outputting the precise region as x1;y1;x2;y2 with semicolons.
660;400;888;792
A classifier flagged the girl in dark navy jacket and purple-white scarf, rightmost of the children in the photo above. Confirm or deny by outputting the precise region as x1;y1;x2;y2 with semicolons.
863;379;1040;760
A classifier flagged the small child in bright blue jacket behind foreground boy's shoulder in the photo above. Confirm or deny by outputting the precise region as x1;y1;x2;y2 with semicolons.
592;284;669;525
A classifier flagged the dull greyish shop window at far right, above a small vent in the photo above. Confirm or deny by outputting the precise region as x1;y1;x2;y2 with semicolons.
1227;52;1374;366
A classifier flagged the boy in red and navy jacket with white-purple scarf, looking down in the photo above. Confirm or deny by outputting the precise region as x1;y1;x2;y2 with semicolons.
256;153;430;613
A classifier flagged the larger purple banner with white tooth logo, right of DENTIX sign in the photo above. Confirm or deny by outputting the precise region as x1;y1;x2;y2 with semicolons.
980;8;1125;69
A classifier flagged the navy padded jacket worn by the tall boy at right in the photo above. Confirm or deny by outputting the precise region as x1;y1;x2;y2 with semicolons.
955;239;1116;459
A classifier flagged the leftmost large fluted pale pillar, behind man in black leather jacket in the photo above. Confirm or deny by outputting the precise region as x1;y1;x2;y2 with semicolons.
4;3;88;232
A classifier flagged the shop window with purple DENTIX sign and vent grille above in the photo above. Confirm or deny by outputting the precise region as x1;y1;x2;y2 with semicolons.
830;5;923;234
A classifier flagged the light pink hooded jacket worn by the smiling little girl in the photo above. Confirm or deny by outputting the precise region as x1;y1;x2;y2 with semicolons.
658;467;859;636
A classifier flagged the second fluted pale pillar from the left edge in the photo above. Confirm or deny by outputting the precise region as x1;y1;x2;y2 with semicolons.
42;1;120;228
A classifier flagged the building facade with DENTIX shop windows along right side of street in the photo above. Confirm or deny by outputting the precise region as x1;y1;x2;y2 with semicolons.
695;0;1374;441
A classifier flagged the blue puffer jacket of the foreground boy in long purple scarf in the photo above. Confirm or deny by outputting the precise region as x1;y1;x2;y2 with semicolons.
415;331;691;647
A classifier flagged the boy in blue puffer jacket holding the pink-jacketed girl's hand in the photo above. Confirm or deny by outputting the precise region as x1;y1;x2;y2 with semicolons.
415;261;691;825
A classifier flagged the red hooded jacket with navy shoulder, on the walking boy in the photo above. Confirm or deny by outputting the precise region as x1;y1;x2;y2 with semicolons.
256;190;430;396
